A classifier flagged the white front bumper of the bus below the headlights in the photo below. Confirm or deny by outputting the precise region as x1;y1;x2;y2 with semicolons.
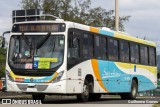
7;80;66;94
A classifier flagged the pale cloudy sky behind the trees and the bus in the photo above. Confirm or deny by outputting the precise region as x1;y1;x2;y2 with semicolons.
0;0;160;54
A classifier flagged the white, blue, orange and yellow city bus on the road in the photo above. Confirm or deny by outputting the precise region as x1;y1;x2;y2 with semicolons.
0;11;157;101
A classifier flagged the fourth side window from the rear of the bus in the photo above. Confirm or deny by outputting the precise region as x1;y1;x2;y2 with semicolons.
120;41;129;62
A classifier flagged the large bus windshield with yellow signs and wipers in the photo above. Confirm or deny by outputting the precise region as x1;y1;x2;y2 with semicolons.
8;33;64;69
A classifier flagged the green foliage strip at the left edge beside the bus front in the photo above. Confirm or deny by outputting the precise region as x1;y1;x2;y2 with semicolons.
0;48;6;78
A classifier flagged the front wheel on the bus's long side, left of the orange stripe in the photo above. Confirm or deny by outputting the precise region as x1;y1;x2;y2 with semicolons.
77;80;89;102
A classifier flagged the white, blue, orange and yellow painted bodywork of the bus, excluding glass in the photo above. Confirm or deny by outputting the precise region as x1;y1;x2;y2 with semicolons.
6;22;157;94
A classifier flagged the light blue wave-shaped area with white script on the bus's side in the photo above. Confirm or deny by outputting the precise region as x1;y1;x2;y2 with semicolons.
98;60;156;92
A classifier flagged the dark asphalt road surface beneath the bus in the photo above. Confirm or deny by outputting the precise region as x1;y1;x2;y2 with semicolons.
0;96;160;105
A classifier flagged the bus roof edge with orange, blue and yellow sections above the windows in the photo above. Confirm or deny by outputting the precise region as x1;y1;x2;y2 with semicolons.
12;20;156;47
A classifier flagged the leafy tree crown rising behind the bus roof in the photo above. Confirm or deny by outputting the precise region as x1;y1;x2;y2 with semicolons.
21;0;130;31
